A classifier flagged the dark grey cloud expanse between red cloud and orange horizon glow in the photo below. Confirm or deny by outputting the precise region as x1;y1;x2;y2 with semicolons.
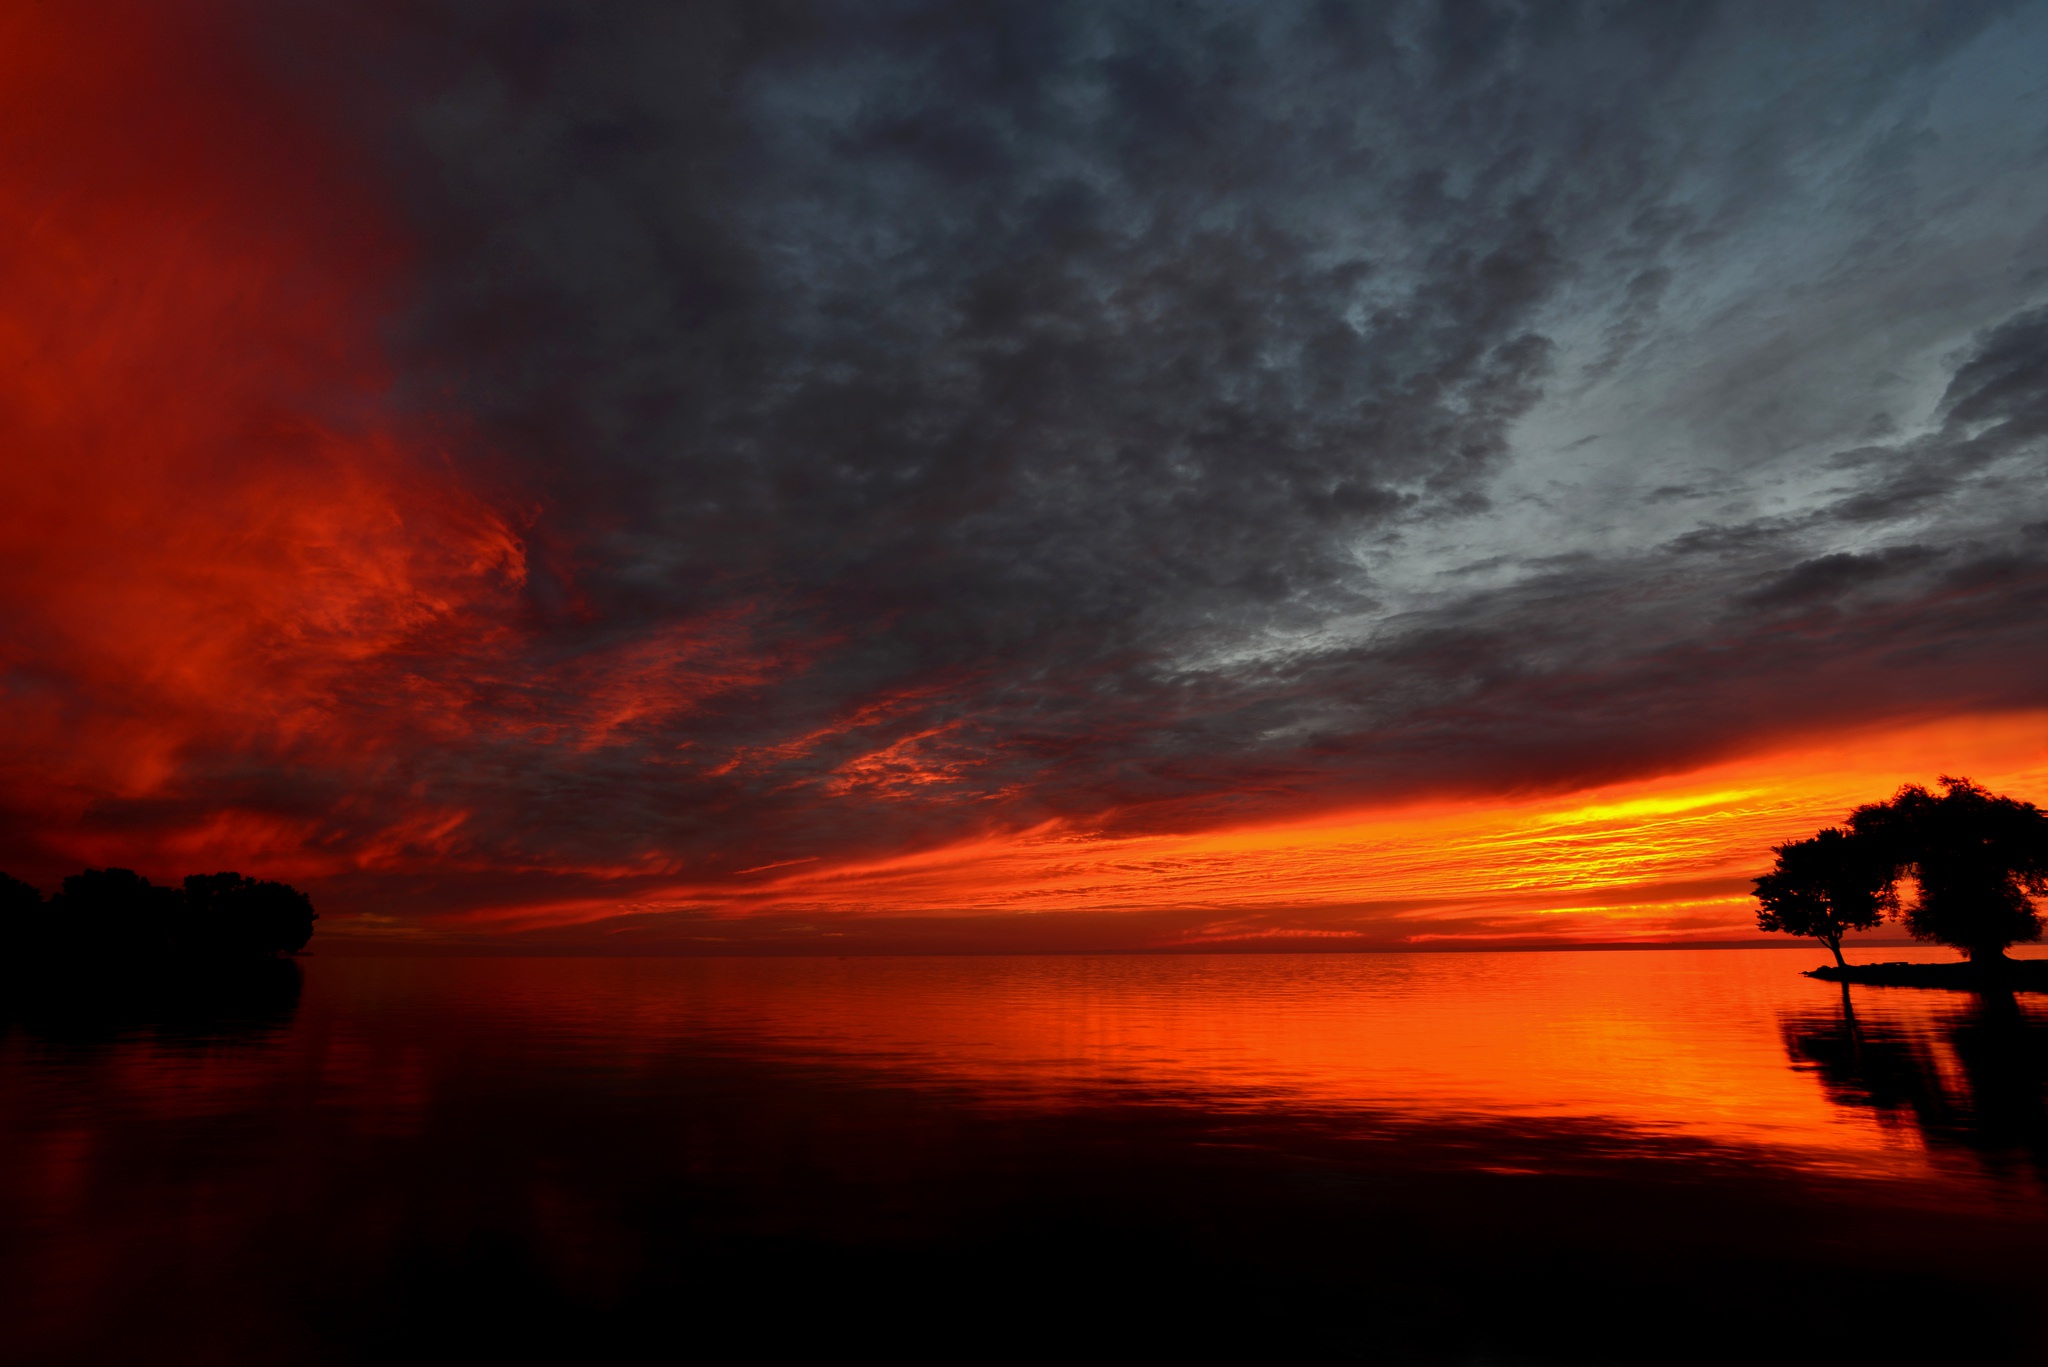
8;0;2048;918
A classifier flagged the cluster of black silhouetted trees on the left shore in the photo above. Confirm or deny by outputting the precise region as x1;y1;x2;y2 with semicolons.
0;869;317;965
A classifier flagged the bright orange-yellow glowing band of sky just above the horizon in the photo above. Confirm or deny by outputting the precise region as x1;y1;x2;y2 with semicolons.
460;713;2048;945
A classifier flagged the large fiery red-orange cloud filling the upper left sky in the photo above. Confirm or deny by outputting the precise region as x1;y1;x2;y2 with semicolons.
0;4;526;855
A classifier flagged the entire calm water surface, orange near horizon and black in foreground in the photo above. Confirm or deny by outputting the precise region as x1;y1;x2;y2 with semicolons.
0;951;2048;1363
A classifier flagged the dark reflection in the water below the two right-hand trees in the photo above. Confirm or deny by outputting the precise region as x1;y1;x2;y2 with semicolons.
1782;984;2048;1176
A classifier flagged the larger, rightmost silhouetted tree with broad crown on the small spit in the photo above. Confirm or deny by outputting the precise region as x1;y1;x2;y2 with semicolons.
1849;775;2048;963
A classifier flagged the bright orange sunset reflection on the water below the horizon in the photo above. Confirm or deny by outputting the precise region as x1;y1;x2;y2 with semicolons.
335;949;2031;1183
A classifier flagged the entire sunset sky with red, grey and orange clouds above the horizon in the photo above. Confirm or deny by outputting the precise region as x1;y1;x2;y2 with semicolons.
0;0;2048;953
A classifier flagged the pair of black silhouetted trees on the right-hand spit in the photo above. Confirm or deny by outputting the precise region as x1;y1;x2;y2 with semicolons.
1757;777;2048;965
